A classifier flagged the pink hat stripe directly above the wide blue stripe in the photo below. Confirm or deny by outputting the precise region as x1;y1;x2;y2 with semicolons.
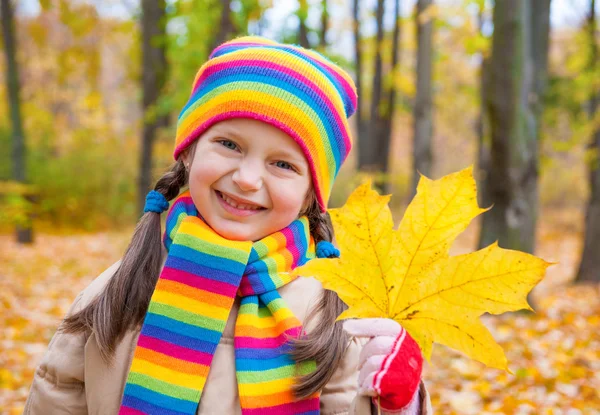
192;59;353;154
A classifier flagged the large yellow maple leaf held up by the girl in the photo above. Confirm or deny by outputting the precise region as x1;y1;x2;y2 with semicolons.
294;167;551;370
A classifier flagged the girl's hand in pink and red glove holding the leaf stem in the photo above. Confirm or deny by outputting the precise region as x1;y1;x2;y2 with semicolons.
344;318;423;412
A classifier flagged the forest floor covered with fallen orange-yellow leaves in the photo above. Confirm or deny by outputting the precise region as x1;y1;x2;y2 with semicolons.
0;212;600;415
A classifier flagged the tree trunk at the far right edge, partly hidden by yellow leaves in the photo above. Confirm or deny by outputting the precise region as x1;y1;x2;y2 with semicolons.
575;0;600;283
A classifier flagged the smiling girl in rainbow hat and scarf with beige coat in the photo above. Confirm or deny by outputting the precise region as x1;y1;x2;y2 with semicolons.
25;37;431;415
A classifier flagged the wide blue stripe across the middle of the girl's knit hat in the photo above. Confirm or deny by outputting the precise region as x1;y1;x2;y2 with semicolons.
179;66;347;169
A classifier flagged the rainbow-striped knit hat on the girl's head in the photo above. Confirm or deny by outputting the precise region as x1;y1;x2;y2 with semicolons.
174;36;357;211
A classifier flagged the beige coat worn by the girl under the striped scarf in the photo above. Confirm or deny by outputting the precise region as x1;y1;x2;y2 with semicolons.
24;263;432;415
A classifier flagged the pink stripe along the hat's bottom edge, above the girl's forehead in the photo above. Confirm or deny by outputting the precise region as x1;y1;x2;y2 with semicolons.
173;111;327;212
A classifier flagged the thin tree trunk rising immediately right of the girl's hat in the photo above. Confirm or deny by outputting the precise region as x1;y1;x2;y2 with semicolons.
352;0;370;170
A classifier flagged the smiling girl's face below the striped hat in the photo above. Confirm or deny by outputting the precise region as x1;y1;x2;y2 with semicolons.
183;118;312;241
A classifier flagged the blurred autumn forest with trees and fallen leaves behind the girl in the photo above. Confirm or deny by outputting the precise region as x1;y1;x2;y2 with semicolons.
0;0;600;415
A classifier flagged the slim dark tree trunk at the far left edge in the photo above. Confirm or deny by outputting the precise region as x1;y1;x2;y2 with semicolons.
0;0;33;244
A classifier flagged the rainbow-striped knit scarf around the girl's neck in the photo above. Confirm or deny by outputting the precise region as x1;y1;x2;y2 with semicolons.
119;192;319;415
